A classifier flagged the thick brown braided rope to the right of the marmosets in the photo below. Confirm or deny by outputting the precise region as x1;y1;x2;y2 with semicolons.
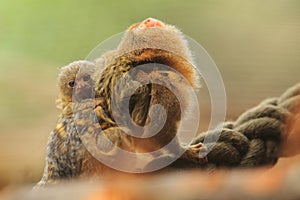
193;84;300;167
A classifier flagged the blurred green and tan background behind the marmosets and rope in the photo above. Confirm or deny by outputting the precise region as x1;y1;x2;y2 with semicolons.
0;0;300;188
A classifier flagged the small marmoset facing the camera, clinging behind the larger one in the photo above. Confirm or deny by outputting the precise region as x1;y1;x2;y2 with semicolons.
37;55;135;187
